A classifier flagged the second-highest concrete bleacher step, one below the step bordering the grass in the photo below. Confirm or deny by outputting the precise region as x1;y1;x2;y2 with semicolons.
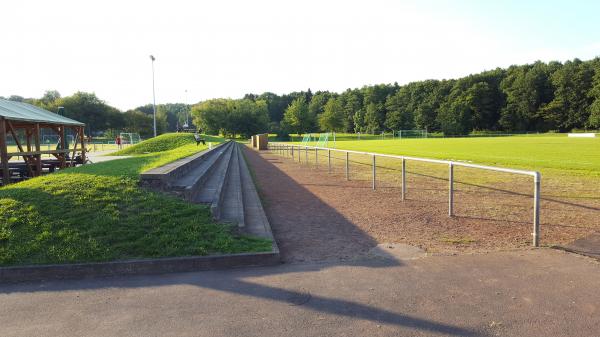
171;143;233;201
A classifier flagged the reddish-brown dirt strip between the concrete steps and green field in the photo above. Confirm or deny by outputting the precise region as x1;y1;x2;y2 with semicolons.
246;145;600;261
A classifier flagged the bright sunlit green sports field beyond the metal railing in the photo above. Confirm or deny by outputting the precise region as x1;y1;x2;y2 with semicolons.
294;135;600;177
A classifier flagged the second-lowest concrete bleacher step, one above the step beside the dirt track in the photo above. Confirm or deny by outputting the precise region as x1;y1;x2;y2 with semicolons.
213;144;245;227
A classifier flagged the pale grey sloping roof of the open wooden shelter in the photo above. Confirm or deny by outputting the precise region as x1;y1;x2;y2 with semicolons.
0;98;84;125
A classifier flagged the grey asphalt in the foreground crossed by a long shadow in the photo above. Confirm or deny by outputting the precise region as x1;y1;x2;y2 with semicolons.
0;249;600;337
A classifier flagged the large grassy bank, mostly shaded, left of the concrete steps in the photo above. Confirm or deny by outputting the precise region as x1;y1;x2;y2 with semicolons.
0;134;271;266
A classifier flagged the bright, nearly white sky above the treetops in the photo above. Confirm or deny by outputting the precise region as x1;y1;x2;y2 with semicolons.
0;0;600;110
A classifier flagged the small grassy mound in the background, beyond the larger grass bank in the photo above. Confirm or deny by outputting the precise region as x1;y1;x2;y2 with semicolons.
110;133;223;156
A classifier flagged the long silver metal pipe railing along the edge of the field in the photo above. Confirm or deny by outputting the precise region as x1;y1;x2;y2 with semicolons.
269;143;542;247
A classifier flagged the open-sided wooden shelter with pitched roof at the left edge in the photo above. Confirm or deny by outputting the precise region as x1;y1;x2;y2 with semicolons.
0;99;86;185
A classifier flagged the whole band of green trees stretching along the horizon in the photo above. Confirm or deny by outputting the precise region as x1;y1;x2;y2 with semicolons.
8;58;600;137
